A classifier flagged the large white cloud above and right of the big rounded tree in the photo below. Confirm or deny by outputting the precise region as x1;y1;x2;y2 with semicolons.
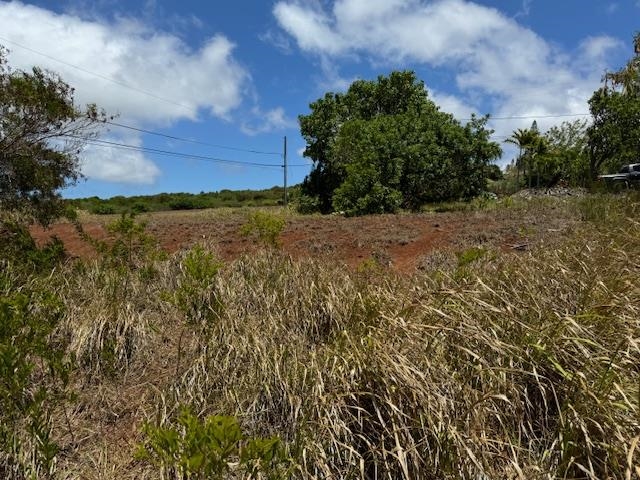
273;0;620;165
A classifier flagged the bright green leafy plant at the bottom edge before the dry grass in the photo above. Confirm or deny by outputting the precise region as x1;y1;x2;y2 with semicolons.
136;409;290;480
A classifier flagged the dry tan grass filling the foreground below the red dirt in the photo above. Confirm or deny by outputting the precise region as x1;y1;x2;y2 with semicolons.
2;193;640;479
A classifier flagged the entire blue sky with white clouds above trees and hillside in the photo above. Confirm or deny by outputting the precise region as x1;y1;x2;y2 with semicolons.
0;0;640;197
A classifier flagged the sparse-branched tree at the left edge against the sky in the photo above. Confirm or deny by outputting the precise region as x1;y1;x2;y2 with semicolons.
0;47;104;225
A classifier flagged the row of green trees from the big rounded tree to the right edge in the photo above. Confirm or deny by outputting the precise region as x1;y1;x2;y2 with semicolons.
299;34;640;214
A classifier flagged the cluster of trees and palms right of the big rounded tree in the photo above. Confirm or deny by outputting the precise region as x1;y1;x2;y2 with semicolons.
480;34;640;193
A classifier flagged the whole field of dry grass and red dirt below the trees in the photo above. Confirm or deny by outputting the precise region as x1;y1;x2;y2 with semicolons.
5;195;640;480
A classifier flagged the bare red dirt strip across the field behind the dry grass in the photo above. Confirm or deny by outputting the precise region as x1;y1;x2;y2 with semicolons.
31;206;569;272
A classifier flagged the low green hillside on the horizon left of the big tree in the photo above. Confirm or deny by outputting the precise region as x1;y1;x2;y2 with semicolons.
69;186;298;215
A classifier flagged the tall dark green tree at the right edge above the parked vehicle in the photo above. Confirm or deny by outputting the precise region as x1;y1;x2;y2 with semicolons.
587;33;640;179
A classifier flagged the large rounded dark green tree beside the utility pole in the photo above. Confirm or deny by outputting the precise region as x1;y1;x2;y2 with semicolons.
300;71;500;214
